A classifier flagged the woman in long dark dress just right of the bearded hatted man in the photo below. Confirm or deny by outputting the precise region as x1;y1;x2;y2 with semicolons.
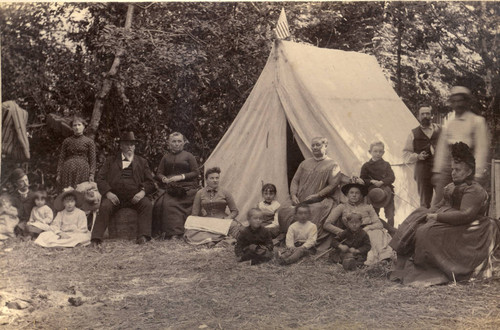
153;132;199;238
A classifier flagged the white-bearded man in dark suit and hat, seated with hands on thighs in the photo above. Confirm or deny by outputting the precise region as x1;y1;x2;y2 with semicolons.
91;132;155;246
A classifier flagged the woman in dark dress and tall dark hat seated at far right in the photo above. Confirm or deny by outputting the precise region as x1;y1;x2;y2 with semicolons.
390;142;500;286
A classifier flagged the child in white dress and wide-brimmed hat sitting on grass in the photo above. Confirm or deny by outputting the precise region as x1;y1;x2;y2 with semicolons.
35;189;90;247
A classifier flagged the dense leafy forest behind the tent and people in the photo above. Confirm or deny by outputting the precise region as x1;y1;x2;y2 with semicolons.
0;1;500;188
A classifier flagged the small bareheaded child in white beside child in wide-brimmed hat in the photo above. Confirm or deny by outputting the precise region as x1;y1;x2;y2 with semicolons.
26;187;54;238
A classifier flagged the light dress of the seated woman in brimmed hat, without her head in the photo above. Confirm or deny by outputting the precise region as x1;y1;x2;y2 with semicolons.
324;202;394;265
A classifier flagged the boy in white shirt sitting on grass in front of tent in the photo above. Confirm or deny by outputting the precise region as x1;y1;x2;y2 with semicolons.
278;204;318;265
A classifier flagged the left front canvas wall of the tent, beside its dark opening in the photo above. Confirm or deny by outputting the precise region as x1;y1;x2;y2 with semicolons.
205;49;291;223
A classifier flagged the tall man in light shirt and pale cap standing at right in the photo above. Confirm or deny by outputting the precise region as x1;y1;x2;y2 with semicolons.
432;86;490;205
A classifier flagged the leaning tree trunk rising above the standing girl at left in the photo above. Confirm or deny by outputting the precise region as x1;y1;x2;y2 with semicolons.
89;4;134;139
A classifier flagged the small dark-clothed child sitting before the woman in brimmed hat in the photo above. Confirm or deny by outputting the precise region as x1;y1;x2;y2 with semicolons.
330;213;371;271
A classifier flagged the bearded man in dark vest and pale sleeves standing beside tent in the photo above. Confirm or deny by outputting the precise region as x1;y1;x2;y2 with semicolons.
403;107;441;208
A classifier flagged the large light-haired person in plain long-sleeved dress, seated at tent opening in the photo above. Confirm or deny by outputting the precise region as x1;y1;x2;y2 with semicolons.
278;137;342;241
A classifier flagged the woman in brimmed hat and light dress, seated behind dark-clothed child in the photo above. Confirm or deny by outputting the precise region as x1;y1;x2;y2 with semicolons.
323;183;394;265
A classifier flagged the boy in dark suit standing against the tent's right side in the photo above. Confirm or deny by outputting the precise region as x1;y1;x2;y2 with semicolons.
359;141;396;227
